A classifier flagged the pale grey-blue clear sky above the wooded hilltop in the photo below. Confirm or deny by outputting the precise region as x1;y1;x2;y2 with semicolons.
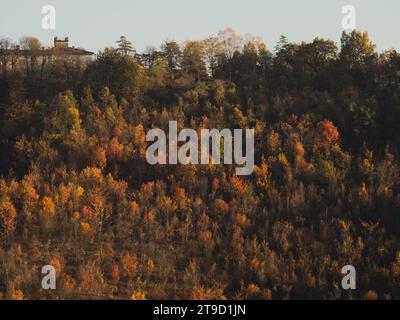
0;0;400;52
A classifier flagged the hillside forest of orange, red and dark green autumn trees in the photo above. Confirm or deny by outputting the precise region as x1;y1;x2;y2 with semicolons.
0;29;400;299
